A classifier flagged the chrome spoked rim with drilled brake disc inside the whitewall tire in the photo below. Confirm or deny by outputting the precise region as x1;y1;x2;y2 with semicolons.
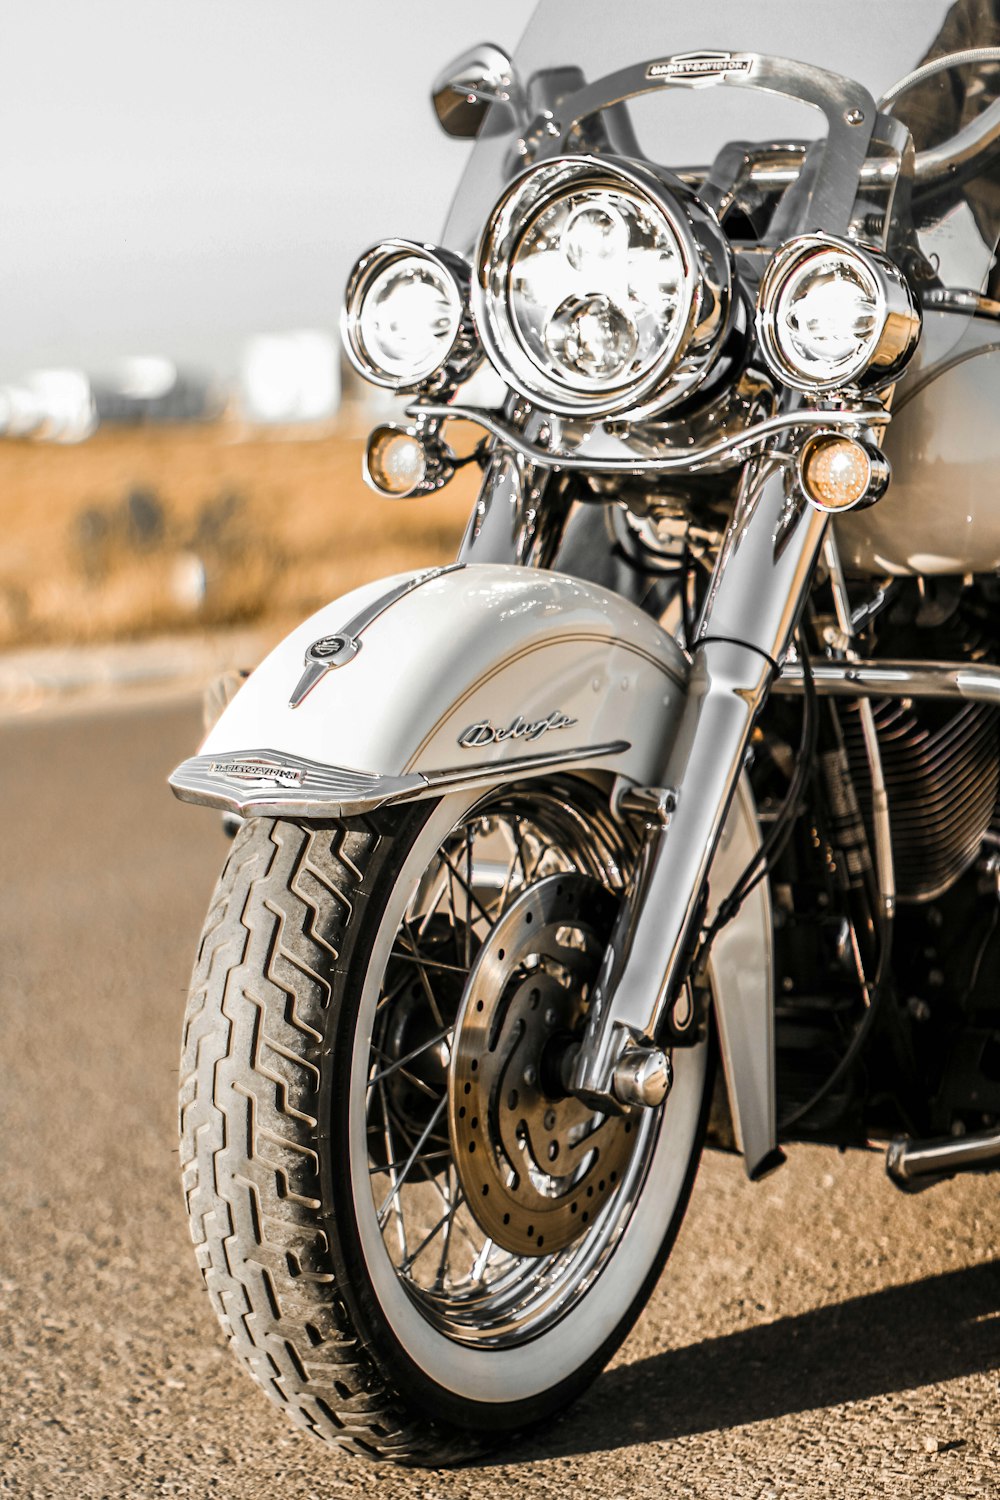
359;788;650;1347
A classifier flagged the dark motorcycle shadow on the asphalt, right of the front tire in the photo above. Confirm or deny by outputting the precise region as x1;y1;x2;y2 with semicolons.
512;1260;1000;1457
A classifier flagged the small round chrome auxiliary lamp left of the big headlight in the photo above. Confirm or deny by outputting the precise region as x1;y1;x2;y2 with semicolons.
342;240;480;390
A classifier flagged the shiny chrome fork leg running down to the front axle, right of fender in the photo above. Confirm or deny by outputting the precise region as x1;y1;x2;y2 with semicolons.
570;464;826;1101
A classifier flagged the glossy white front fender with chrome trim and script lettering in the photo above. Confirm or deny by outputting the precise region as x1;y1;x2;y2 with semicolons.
171;564;775;1175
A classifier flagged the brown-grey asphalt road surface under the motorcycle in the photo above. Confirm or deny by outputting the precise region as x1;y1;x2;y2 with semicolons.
0;707;1000;1500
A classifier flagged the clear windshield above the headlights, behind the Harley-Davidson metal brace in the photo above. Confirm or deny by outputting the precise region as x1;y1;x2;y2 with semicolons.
445;0;1000;357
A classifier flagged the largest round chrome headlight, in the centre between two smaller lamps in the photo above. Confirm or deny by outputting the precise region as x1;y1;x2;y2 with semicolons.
472;156;732;417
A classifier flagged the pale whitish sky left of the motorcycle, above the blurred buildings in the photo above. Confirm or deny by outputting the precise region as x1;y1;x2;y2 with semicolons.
0;0;532;380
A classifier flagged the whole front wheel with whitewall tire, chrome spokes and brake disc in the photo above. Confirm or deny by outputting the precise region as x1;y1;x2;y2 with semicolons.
180;780;709;1464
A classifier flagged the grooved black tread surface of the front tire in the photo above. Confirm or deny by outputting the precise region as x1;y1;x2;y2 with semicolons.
180;819;478;1464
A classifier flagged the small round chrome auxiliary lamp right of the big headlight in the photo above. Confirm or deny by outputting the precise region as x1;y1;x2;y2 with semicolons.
757;234;921;392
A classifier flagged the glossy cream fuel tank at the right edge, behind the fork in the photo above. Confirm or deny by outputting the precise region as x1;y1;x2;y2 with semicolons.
837;312;1000;578
